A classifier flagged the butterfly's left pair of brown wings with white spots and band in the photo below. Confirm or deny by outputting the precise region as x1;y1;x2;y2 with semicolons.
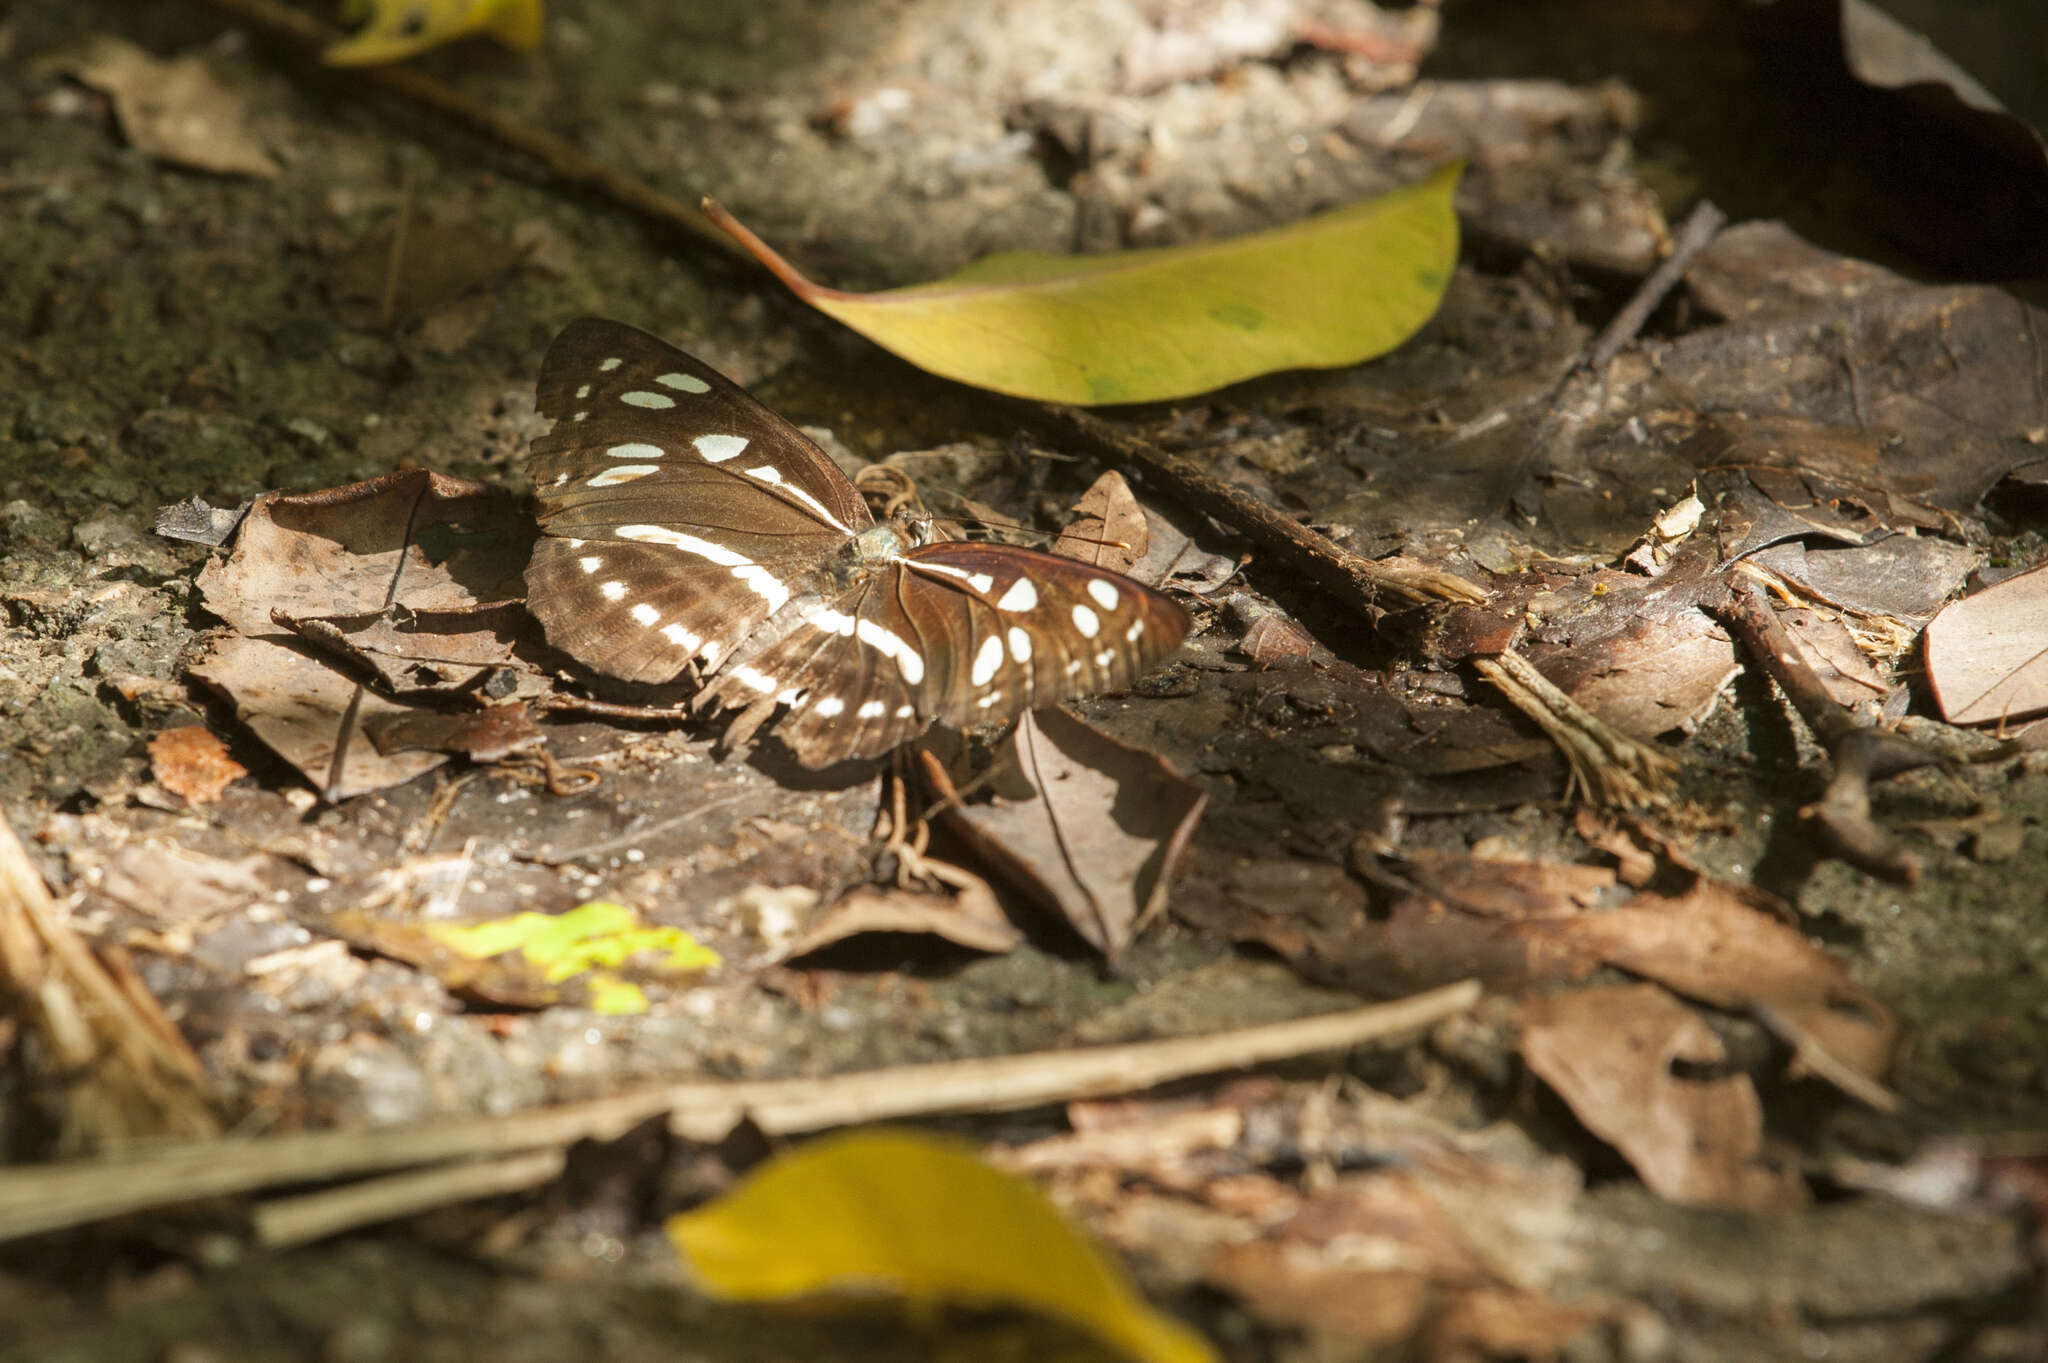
526;317;870;682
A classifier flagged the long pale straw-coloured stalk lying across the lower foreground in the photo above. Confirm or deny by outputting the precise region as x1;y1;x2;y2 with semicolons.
0;980;1481;1240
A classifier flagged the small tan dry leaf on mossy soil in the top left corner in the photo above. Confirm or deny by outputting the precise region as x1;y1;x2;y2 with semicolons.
57;37;281;180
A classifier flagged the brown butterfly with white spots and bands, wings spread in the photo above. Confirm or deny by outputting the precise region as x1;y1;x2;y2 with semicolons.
526;317;1188;767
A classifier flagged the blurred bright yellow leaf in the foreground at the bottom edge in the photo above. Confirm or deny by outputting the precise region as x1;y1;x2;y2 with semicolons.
668;1132;1217;1363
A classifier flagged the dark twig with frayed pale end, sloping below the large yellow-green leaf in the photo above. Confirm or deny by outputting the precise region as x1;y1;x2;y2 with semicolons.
1042;407;1487;618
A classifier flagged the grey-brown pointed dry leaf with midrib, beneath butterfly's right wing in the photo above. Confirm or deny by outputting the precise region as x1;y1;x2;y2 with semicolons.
920;710;1208;960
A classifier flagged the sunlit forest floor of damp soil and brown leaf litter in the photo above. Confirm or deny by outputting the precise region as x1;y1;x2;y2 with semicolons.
0;0;2048;1363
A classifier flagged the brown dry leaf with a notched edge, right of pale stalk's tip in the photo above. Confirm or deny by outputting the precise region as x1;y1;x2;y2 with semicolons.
1520;984;1806;1212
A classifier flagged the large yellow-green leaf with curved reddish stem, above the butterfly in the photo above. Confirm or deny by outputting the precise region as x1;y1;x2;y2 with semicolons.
705;164;1460;403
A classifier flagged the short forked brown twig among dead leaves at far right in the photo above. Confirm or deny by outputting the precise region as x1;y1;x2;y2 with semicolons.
1714;573;1942;884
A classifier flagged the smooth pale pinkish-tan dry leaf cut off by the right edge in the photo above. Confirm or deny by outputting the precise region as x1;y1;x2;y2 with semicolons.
1925;569;2048;724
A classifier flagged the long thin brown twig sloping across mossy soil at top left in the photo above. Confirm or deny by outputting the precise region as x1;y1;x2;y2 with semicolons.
199;0;754;264
